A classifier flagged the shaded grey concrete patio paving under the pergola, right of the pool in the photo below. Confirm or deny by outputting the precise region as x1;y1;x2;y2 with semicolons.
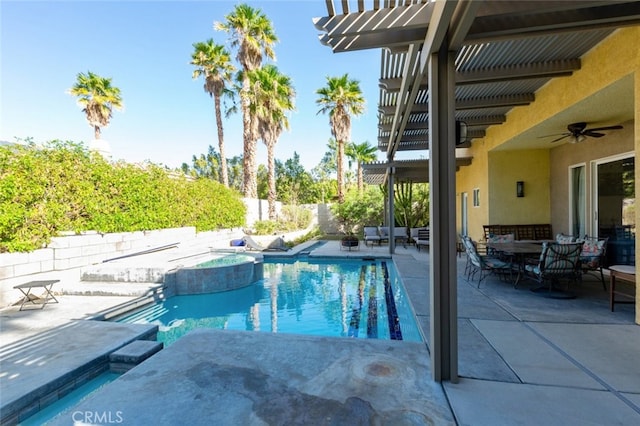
394;250;640;425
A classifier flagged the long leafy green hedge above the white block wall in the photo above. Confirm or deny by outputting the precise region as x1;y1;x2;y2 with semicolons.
0;141;246;252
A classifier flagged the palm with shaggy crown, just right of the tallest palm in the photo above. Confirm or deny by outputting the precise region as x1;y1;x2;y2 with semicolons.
249;65;295;220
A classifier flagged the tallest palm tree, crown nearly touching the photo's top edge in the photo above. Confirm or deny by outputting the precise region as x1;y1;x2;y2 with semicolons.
214;3;278;198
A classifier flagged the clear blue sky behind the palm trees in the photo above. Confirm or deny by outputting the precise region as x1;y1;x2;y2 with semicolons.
0;0;383;170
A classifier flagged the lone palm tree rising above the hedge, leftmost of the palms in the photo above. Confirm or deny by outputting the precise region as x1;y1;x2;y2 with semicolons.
69;71;122;139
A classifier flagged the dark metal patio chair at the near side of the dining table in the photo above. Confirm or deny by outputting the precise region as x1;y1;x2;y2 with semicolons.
525;242;582;293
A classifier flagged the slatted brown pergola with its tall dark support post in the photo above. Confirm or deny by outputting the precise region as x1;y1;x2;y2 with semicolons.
314;0;640;381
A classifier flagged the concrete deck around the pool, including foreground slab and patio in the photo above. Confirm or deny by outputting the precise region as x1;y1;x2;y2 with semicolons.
0;241;640;425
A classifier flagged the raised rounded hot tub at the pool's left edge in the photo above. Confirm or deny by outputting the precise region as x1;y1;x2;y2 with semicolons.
164;253;264;295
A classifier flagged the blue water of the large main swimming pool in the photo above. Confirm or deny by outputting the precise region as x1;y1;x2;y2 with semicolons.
120;259;422;345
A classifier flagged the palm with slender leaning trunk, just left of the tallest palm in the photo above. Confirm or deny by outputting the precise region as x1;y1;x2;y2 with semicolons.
191;39;235;187
